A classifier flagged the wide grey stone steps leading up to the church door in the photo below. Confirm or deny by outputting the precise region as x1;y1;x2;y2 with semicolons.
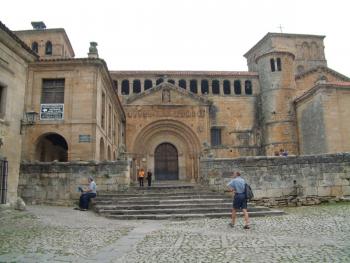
94;182;284;220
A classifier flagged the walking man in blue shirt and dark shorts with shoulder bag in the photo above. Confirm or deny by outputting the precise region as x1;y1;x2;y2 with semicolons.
227;172;250;229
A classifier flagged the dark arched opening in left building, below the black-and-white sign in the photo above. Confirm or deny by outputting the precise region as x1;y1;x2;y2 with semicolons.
35;133;68;162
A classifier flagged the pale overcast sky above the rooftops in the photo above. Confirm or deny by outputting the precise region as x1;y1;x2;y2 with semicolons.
0;0;350;76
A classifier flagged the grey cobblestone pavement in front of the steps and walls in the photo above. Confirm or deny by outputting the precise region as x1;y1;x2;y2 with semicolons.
0;203;350;263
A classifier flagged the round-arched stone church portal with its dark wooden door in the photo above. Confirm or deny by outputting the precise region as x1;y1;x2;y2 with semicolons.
131;120;200;182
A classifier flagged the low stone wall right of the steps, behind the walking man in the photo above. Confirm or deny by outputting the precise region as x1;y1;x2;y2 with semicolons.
200;153;350;199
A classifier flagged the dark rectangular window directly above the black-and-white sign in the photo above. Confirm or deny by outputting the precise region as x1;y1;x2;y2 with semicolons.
41;79;64;104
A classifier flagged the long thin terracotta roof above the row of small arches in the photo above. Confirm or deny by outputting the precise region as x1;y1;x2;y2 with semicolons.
110;70;259;77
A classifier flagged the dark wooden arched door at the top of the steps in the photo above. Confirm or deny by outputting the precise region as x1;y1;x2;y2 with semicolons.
154;143;179;180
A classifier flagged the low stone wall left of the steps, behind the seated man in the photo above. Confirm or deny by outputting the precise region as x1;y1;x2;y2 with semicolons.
18;160;130;205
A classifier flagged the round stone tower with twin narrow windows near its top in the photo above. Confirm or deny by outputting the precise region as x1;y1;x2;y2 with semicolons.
256;51;298;155
